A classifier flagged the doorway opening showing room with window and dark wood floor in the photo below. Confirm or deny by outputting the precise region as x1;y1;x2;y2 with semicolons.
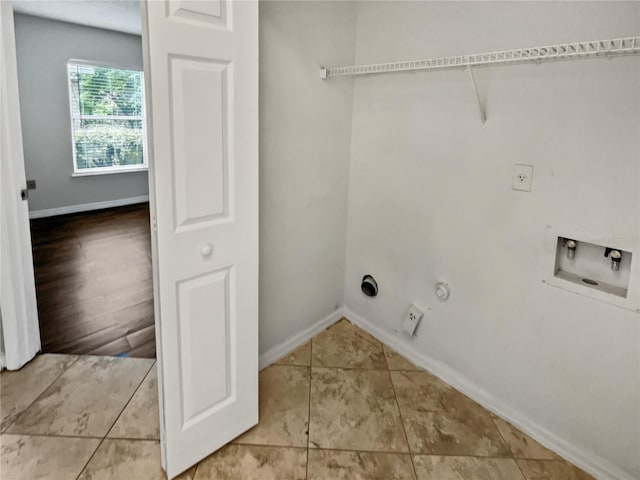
14;1;156;358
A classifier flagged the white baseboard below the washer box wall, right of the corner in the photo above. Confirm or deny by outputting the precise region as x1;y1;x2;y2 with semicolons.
344;307;634;480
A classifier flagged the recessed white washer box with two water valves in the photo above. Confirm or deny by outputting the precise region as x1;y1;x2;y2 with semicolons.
541;226;640;312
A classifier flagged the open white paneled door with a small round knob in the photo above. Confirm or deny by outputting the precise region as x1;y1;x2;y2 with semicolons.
143;0;258;477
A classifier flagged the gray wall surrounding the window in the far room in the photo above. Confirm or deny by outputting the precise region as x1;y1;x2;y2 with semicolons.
15;14;148;211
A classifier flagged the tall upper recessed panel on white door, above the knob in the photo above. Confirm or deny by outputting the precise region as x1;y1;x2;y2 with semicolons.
169;55;234;230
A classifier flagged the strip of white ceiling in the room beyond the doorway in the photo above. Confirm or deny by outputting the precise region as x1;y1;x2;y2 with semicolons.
13;0;141;35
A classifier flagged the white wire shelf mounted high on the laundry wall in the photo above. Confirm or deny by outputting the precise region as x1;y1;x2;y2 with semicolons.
320;36;640;78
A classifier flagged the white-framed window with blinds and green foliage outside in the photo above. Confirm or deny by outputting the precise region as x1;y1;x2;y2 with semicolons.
67;62;147;174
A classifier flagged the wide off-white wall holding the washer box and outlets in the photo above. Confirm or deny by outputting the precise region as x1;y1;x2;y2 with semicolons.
344;2;640;478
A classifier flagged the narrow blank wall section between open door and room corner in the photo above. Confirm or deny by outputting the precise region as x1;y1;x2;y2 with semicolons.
260;1;355;354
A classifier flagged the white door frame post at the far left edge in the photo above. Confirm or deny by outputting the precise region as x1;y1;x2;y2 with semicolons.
0;1;40;370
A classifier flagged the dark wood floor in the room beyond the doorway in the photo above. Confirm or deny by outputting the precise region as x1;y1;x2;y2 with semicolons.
31;204;156;357
